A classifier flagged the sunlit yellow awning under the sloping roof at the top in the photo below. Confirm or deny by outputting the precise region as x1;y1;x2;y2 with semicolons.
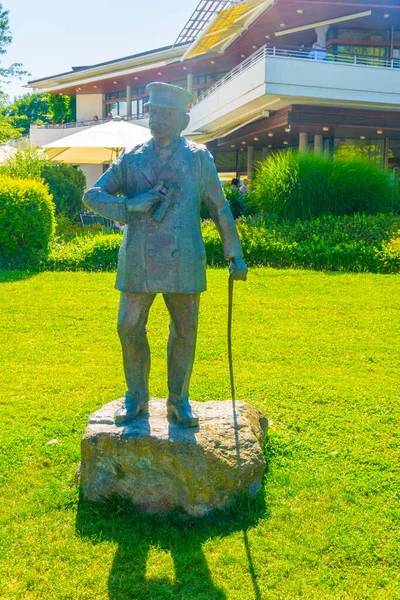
181;0;274;61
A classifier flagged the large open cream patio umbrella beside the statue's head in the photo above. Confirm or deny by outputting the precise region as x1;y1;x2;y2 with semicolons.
43;118;151;165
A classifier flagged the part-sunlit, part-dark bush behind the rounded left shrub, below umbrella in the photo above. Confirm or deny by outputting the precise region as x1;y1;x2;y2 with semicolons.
2;146;86;217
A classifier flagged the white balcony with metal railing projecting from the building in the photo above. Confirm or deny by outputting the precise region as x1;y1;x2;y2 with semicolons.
185;45;400;140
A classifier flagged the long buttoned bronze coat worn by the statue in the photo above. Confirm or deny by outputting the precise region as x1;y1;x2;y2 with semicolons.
84;138;242;294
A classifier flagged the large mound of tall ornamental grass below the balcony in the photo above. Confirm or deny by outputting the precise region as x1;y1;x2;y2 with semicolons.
250;151;400;220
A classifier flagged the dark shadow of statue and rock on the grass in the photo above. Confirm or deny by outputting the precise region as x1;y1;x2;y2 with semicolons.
76;450;269;600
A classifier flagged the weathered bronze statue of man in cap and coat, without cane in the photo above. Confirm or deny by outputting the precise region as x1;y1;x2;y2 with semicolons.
84;83;247;427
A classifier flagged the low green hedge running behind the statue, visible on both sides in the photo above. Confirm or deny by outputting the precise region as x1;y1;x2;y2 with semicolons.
47;215;400;273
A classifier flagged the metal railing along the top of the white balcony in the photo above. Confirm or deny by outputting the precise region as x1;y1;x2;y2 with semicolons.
193;44;400;106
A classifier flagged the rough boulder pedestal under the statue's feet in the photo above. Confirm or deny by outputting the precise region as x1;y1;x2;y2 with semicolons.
80;399;268;516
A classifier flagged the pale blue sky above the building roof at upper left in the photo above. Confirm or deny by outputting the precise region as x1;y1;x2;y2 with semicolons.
1;0;199;100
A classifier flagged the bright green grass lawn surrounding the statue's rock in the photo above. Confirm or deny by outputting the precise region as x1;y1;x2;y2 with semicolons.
0;268;400;600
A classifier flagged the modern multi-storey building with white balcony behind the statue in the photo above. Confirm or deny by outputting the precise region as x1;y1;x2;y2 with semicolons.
30;0;400;183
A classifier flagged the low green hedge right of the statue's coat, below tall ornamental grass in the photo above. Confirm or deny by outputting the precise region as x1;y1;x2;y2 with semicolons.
203;215;400;273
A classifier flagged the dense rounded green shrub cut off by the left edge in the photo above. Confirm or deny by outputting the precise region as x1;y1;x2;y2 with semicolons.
0;175;54;268
